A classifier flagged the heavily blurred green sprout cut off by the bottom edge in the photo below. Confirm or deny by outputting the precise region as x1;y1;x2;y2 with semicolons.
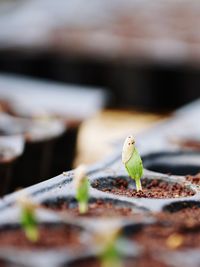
98;229;122;267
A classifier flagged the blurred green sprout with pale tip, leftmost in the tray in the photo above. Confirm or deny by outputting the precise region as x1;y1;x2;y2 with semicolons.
17;195;39;242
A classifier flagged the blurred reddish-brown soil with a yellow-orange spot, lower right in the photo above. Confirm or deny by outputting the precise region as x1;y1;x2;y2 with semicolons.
129;224;200;253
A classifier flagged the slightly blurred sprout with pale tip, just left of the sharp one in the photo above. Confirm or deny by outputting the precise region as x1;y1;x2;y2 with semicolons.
74;165;89;214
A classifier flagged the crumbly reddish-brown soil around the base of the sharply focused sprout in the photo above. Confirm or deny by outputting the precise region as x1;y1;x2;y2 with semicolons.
93;178;195;198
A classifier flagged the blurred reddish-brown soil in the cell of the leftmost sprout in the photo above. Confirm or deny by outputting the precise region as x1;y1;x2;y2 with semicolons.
0;225;81;249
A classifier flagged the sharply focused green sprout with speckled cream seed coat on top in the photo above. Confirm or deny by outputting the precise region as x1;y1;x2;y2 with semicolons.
122;136;143;191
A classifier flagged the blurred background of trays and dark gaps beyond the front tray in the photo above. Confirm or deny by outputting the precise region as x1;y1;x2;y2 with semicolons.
0;0;200;195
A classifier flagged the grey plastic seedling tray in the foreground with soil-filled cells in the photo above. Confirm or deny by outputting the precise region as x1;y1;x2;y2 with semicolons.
0;101;200;267
